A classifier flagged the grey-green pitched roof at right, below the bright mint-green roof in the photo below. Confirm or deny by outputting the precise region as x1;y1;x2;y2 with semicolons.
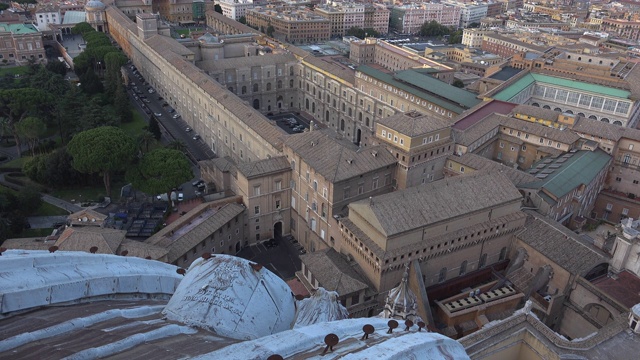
522;149;611;198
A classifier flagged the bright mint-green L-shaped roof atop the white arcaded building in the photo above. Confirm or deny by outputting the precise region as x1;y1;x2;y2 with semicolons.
493;73;631;101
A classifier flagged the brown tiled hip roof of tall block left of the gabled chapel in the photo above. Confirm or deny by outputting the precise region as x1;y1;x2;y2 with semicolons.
285;130;396;183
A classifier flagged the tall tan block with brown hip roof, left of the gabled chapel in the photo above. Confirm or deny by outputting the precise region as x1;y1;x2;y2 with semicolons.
283;130;396;252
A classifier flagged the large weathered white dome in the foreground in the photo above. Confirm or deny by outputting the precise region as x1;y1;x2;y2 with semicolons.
163;255;296;340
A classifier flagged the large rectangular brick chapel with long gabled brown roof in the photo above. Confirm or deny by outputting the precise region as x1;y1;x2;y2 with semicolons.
336;172;525;293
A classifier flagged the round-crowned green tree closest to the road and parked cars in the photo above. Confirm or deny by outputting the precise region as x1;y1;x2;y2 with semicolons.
127;148;193;204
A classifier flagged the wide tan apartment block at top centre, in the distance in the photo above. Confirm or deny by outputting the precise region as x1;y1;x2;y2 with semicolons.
246;6;331;44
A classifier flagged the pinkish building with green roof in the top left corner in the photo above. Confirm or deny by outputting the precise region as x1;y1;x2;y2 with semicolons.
0;23;47;65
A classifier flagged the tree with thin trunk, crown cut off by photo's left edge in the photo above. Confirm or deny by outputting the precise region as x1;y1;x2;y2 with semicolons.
0;88;53;153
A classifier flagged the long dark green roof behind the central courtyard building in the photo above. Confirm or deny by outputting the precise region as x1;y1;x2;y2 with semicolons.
357;65;480;114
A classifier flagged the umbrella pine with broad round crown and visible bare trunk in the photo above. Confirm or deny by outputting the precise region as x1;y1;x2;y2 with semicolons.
67;126;136;196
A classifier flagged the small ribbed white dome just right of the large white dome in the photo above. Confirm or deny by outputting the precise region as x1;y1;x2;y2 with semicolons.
294;288;349;328
